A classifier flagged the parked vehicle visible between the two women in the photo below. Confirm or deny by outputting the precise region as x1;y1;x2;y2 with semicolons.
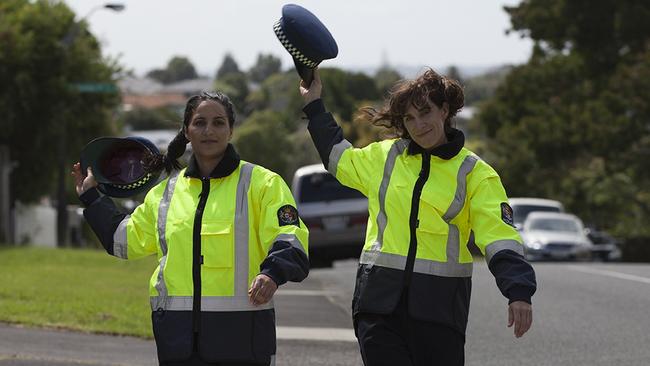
292;164;368;266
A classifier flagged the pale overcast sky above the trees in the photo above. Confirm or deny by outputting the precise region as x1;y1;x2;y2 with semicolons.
64;0;532;76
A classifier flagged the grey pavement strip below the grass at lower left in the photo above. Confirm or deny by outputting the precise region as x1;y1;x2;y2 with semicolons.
0;323;158;366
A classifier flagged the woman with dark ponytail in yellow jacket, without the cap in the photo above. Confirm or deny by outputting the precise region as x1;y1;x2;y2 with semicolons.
73;92;309;365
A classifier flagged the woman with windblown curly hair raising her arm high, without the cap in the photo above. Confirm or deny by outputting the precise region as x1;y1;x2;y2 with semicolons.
300;69;536;366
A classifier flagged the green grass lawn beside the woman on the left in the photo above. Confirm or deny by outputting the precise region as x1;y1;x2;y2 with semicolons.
0;247;157;338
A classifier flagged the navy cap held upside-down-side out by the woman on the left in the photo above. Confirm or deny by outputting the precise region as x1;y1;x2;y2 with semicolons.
81;136;160;198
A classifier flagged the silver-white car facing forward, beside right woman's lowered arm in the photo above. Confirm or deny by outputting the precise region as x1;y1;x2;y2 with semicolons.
521;212;593;260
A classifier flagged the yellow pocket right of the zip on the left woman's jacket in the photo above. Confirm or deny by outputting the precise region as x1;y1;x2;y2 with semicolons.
201;220;235;268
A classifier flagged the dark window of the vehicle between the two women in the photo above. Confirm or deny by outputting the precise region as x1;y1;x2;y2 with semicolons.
300;173;366;202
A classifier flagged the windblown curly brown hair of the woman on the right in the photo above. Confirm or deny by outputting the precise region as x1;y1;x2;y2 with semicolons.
358;68;465;138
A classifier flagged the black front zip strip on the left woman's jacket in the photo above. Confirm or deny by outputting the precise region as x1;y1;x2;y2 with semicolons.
192;178;210;333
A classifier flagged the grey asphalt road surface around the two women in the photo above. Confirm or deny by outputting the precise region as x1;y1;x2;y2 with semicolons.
0;261;650;366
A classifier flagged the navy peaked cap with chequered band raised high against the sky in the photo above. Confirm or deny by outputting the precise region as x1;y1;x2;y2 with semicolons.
273;4;339;84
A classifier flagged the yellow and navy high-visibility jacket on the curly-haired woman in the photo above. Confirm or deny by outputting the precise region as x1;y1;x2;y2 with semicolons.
305;100;536;333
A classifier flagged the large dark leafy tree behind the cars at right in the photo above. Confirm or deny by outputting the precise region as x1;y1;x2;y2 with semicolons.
478;0;650;238
